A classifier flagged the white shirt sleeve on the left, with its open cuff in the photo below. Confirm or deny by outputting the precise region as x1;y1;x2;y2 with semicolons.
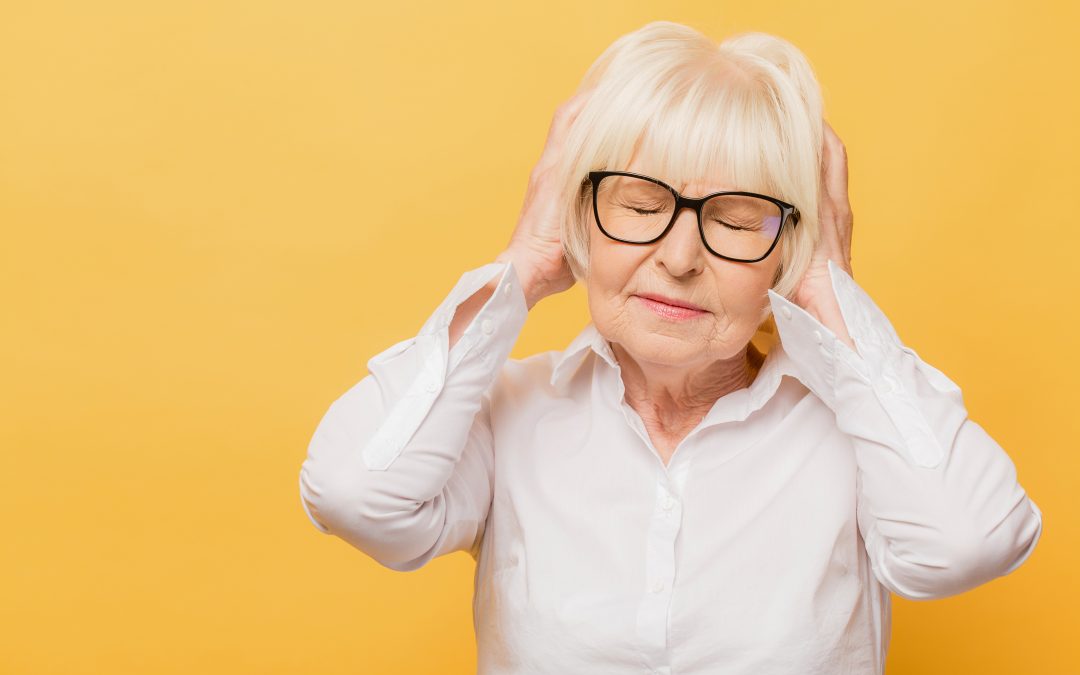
299;261;528;571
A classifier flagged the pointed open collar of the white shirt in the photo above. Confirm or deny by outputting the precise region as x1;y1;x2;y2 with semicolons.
550;319;798;422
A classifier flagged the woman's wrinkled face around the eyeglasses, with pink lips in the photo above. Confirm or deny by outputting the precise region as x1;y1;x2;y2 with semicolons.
585;157;780;368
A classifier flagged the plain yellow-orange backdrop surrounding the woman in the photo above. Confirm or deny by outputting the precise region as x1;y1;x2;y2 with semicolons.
0;0;1080;675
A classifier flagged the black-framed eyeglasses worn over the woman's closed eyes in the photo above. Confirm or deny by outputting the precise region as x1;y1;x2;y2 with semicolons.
589;171;799;262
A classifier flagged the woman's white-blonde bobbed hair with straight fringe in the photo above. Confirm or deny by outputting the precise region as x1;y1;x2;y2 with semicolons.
554;21;824;298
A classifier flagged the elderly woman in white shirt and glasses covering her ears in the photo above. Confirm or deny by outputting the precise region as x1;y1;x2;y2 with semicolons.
300;22;1042;675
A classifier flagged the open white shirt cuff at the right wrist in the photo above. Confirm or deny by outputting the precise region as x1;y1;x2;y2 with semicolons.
769;260;966;468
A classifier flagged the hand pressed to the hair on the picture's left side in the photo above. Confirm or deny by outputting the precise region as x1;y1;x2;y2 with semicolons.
496;91;591;309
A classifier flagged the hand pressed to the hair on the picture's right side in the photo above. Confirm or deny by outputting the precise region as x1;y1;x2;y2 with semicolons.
792;122;855;350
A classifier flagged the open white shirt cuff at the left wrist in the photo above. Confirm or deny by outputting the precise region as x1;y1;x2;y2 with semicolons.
362;261;528;471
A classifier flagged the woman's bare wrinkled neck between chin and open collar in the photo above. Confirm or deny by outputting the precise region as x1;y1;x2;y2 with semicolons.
611;342;765;431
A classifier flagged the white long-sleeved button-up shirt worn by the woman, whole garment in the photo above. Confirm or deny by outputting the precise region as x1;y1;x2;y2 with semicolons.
300;262;1042;675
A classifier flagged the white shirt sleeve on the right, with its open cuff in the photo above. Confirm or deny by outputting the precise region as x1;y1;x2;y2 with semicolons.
769;260;1042;599
